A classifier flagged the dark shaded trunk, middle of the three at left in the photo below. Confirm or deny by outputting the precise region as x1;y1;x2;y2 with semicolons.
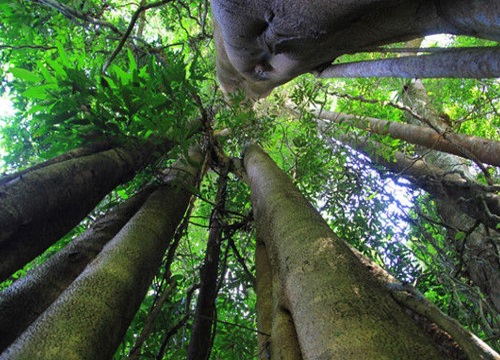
0;188;153;352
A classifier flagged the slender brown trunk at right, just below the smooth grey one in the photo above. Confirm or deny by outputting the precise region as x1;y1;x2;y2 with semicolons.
316;110;500;166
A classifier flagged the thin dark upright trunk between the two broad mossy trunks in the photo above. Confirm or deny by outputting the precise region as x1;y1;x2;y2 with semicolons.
187;166;228;360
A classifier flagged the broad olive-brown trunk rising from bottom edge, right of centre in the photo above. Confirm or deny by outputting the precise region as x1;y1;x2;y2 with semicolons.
244;145;442;360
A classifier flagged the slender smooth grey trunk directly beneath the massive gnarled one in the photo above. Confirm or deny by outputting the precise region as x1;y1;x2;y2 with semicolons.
318;47;500;79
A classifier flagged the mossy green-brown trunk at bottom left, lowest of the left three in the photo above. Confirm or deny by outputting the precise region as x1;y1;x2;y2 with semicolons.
0;147;201;360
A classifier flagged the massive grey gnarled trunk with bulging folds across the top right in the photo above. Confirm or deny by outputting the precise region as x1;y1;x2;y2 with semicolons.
212;0;500;98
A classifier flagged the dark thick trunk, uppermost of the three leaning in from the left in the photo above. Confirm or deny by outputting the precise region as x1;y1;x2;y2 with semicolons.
0;138;171;281
